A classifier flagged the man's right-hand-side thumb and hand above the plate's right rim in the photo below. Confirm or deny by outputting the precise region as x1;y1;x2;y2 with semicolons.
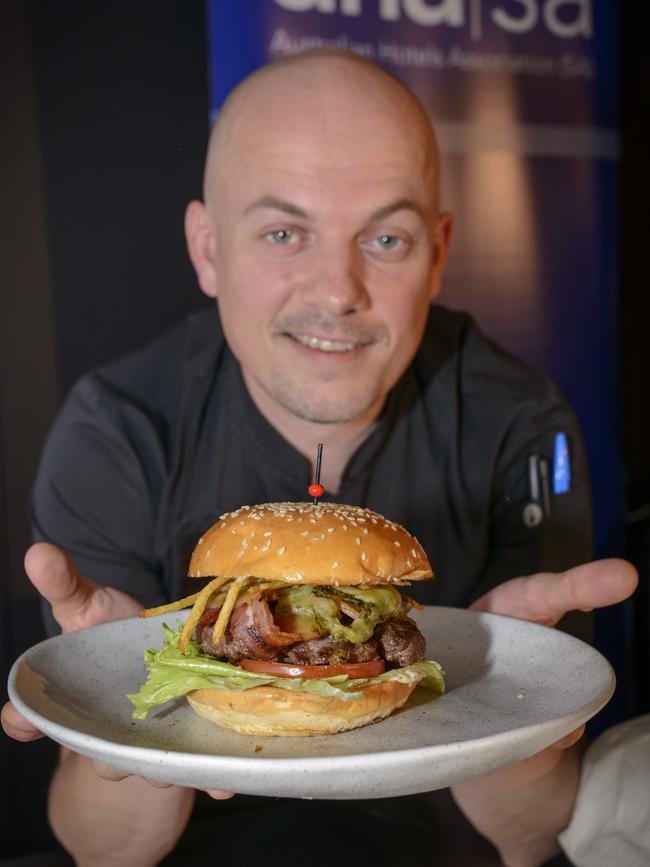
471;559;638;626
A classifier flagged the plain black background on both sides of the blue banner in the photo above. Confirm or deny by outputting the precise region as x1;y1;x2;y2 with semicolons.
0;0;650;863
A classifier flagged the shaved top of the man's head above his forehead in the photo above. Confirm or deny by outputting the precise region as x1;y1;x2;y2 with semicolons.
204;49;439;214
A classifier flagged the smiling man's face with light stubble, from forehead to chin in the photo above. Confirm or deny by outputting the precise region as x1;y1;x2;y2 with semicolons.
190;75;447;423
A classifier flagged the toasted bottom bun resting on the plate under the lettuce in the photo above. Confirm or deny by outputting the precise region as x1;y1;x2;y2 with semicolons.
187;680;416;736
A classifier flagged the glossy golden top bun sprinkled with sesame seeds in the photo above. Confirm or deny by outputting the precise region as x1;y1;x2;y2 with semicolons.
189;503;433;586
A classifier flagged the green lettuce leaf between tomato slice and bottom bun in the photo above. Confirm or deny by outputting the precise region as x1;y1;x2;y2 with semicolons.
127;624;445;719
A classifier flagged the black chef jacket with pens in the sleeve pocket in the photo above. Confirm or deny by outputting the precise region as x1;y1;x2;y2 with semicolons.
32;306;591;630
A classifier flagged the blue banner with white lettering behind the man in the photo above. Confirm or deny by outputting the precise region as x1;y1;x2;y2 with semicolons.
208;0;622;555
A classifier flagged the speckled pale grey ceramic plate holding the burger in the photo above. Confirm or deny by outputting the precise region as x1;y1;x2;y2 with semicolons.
9;608;614;798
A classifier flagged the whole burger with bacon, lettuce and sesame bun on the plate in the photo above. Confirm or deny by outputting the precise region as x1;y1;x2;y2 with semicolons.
129;502;444;736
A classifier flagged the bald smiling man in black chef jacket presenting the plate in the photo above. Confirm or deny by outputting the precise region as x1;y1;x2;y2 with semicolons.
3;52;629;867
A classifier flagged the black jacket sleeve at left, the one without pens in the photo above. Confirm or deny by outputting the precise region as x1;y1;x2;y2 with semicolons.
31;374;165;634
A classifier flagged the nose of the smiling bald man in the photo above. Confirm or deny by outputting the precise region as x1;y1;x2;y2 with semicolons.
306;242;370;316
